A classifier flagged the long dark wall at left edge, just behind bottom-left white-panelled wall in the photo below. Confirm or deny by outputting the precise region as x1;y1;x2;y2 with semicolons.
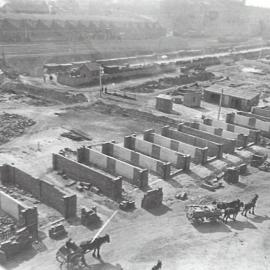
1;165;77;218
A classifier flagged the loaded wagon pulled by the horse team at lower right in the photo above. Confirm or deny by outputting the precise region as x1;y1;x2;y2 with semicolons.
186;205;222;224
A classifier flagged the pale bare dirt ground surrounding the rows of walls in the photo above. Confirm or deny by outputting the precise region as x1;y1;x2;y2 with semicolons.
0;56;270;270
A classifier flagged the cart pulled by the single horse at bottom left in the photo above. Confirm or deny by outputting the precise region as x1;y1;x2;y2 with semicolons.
56;246;85;270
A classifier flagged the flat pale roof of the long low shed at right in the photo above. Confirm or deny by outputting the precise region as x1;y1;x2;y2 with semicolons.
204;85;260;100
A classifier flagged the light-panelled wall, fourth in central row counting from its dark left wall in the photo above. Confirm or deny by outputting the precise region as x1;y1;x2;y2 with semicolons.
124;129;191;170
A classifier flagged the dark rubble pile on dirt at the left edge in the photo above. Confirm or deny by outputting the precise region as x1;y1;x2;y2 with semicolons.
0;113;35;144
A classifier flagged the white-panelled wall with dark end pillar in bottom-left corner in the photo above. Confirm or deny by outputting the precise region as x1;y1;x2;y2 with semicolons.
0;191;38;238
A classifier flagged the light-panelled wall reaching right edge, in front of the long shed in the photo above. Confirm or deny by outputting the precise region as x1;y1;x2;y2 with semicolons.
226;113;270;138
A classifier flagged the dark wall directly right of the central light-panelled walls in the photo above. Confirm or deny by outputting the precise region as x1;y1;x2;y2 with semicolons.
161;126;223;158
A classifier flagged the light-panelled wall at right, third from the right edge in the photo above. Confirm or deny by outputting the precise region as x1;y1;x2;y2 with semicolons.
203;118;260;144
